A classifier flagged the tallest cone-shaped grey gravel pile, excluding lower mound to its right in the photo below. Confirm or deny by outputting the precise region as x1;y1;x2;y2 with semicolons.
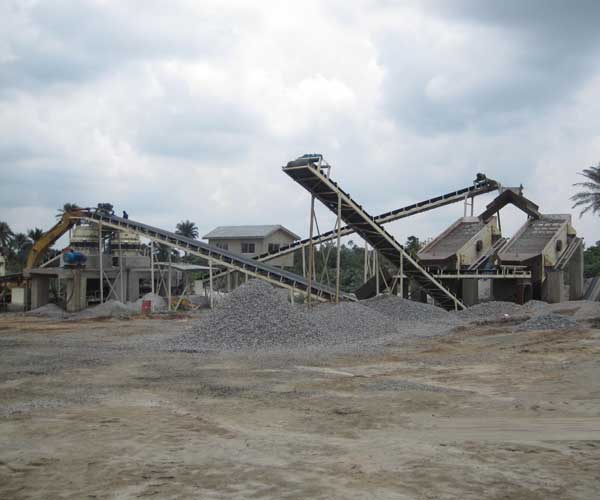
175;280;319;350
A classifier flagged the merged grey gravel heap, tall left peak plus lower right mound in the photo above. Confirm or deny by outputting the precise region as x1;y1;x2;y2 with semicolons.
172;280;472;352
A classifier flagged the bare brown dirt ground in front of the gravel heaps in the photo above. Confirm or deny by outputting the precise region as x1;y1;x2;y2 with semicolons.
0;315;600;500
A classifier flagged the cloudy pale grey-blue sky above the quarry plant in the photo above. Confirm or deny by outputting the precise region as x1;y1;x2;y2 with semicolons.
0;0;600;244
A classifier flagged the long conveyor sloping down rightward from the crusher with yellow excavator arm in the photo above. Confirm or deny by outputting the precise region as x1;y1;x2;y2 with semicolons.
74;210;356;300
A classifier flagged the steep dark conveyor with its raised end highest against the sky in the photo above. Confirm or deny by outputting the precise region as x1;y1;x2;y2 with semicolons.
283;161;465;309
